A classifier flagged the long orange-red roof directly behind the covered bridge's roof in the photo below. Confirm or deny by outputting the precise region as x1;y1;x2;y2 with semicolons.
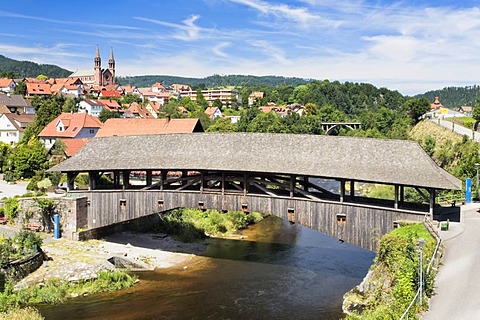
95;118;203;137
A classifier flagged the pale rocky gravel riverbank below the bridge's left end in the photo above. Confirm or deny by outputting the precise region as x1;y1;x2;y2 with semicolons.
16;232;206;288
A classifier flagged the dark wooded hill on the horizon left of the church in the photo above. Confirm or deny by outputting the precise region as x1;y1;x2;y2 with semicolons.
0;55;72;78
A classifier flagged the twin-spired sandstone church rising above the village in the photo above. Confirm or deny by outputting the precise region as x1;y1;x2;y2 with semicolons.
69;46;116;87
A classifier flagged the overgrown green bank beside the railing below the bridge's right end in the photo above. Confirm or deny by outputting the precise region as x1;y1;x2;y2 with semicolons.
344;224;436;320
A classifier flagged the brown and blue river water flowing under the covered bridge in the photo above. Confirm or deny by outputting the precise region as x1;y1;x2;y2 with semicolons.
40;217;375;320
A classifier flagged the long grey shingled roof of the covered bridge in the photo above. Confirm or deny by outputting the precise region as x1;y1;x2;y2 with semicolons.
50;133;462;190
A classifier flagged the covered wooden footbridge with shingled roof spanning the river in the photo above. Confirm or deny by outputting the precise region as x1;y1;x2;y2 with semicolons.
50;133;462;250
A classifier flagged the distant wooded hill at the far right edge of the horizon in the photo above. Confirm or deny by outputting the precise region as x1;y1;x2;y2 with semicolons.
415;85;480;107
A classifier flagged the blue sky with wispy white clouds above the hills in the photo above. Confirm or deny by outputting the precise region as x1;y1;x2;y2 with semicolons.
0;0;480;95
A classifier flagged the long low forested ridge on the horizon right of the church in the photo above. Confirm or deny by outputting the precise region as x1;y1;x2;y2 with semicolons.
117;75;310;90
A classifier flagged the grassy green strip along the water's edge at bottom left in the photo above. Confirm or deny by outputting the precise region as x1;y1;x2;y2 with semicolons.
0;271;136;319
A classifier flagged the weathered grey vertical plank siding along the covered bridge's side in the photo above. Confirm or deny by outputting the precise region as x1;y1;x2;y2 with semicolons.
72;190;426;251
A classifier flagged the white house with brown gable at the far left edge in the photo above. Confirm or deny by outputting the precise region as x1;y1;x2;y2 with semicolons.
0;113;35;145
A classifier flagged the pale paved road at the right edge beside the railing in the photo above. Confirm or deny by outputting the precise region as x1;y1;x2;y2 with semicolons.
422;203;480;320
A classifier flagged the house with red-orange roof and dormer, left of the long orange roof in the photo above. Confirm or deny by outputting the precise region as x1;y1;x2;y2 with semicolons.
38;113;102;149
